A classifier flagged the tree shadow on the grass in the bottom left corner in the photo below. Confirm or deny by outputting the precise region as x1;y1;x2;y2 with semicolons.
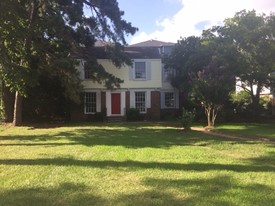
0;183;106;206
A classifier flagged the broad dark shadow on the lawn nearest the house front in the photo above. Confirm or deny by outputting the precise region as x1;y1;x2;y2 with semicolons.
68;127;272;148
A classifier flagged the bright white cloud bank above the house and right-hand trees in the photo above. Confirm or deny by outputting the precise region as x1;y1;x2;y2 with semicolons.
131;0;275;44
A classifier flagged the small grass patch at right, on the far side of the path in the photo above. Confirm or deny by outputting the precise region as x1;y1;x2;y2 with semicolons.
215;123;275;140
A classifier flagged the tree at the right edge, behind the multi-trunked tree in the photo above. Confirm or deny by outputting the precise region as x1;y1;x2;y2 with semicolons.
217;10;275;117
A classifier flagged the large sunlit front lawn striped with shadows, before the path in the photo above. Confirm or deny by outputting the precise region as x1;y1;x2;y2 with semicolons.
0;123;275;206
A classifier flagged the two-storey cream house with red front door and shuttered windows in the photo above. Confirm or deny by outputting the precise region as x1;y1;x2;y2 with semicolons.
71;40;180;120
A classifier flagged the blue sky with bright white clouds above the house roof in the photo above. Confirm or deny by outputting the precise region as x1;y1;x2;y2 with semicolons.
117;0;275;44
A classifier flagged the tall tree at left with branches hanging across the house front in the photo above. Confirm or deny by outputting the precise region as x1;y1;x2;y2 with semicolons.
0;0;137;125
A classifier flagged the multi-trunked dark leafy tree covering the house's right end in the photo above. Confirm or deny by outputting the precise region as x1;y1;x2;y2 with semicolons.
165;36;236;127
